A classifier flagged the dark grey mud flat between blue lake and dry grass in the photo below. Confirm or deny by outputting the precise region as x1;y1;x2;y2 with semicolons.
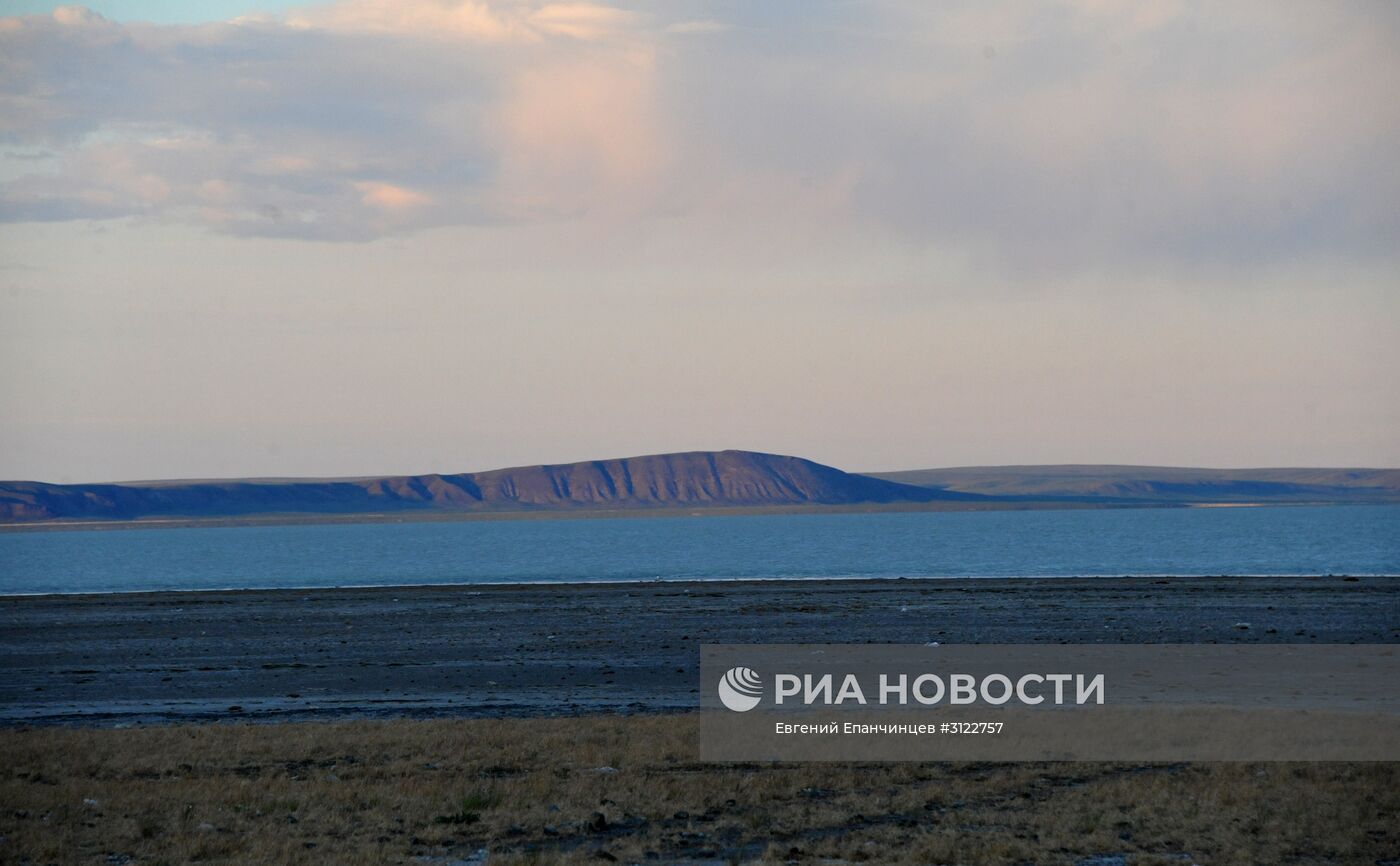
0;576;1400;725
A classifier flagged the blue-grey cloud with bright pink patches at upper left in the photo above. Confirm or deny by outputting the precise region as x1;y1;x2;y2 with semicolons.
0;0;655;241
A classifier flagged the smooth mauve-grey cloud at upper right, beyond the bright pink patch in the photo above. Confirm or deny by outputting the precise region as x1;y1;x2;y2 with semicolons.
658;3;1400;270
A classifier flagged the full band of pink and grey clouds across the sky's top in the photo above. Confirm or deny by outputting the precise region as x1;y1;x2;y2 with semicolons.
0;0;1400;269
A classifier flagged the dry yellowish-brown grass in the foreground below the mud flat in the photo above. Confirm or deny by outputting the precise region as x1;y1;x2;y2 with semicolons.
0;716;1400;866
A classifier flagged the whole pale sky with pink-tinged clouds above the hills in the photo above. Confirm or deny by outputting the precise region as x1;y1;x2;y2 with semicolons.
0;0;1400;481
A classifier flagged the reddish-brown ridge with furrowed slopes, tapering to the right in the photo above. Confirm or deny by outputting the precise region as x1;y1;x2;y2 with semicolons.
0;450;983;523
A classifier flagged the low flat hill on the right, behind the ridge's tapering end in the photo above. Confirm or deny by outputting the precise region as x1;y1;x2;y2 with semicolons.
869;464;1400;504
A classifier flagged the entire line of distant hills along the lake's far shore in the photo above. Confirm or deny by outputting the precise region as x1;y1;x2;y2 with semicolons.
0;450;1400;525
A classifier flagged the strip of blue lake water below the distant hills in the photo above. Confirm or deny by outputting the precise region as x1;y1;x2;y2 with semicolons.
0;505;1400;595
